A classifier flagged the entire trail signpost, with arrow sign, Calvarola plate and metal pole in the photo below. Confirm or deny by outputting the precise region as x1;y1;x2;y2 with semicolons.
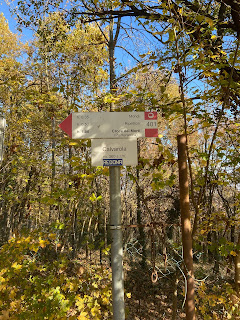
59;112;158;320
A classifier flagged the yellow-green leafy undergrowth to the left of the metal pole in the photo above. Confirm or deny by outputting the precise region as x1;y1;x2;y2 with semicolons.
0;231;111;320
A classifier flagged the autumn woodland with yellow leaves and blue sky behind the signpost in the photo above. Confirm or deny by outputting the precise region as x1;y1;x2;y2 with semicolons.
0;0;240;320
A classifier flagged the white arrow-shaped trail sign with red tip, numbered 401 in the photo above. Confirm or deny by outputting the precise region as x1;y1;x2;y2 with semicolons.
59;112;158;139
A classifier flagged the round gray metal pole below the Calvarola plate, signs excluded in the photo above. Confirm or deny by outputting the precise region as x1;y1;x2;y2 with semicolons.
109;166;125;320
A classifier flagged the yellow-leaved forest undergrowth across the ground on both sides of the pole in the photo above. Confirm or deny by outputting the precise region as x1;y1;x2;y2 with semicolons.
0;231;240;320
